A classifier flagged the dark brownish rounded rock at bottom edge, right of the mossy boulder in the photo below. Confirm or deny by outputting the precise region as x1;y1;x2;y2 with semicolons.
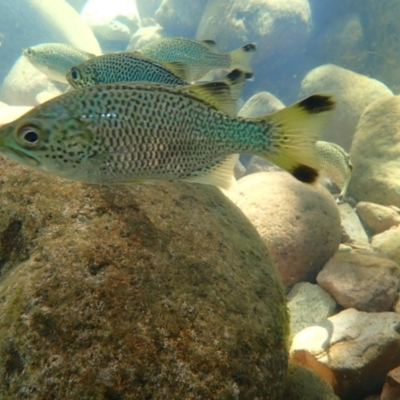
282;363;340;400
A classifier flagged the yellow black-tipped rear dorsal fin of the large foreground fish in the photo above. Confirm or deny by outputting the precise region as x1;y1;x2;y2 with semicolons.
188;69;246;115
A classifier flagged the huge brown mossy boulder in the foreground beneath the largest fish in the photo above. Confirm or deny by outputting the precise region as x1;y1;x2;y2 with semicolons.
0;159;288;400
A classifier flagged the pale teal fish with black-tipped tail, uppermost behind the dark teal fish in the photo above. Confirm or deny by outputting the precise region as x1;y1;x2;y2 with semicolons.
138;37;256;81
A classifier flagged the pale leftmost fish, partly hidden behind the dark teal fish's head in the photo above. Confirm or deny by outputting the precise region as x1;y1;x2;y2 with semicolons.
22;43;95;83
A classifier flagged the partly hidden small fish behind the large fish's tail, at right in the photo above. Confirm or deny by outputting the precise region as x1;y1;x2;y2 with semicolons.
316;140;353;203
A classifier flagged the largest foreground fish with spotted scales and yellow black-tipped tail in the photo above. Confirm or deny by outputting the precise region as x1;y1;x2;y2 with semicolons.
0;70;334;189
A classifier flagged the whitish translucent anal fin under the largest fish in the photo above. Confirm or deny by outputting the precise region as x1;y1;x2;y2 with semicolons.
180;154;239;190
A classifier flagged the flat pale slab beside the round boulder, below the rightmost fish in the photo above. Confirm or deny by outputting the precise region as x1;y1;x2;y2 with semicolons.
339;203;370;249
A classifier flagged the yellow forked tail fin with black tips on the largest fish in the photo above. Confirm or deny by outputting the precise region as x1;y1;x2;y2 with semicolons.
259;94;335;183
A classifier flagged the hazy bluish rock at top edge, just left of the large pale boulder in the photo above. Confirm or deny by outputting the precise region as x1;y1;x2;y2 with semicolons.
155;0;208;39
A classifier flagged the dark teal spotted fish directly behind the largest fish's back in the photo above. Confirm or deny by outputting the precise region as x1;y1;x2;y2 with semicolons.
67;52;188;88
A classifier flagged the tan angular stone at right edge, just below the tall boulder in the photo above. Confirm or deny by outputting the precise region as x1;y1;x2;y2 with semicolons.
356;201;400;235
